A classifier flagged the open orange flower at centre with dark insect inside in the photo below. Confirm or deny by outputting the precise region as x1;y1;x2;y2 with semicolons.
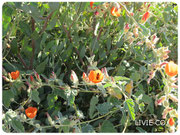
88;70;104;83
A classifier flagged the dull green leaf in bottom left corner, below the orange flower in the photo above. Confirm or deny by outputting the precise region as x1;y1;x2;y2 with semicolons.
11;118;25;133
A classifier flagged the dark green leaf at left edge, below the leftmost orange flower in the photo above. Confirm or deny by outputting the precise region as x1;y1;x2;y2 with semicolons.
3;90;14;108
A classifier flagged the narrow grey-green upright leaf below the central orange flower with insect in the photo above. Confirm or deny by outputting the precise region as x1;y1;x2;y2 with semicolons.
89;96;99;119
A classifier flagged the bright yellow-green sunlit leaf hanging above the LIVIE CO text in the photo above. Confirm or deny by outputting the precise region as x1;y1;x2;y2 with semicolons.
124;99;135;120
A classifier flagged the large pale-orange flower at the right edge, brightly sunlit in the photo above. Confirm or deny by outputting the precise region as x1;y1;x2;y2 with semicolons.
165;61;178;77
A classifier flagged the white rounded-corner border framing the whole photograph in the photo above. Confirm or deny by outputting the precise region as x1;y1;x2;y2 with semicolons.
0;0;180;135
